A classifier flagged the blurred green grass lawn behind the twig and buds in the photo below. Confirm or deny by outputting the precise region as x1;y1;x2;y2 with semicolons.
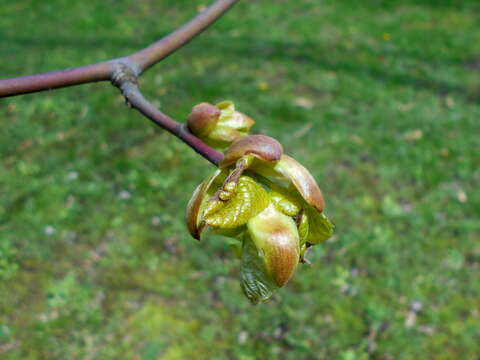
0;0;480;360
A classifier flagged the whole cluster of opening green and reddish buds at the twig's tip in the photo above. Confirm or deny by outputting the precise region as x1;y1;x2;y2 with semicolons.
187;110;333;303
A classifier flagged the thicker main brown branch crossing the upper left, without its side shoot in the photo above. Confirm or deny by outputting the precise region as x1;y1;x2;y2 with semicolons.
0;0;239;98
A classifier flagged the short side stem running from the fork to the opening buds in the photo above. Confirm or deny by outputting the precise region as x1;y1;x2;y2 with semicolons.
120;81;223;166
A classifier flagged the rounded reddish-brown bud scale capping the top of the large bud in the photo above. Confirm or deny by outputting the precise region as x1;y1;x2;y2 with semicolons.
219;135;283;168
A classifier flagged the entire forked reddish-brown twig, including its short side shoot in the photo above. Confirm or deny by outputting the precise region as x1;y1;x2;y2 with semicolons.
0;0;239;165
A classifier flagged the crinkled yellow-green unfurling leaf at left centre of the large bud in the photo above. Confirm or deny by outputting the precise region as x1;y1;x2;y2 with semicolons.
203;175;269;229
